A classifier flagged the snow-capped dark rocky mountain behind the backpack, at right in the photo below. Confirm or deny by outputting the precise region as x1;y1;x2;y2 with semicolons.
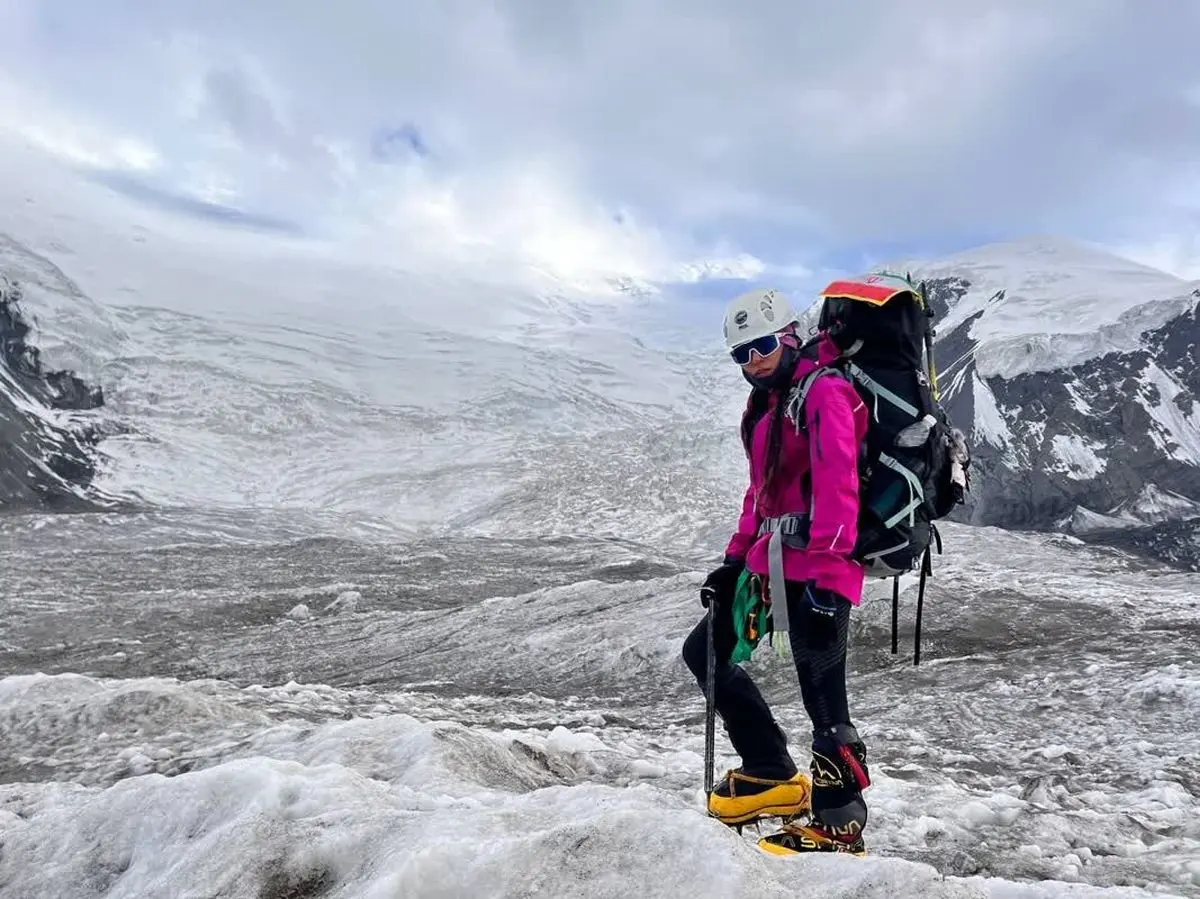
912;240;1200;564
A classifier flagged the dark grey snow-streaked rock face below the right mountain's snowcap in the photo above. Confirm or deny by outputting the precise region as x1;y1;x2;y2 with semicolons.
928;255;1200;570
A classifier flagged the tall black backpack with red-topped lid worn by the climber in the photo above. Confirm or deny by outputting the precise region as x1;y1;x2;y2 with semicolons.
793;272;971;664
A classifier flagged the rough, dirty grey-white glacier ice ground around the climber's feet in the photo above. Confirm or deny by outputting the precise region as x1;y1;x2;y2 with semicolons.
0;517;1200;897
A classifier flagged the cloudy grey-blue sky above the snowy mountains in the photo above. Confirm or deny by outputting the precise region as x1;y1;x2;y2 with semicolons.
0;0;1200;285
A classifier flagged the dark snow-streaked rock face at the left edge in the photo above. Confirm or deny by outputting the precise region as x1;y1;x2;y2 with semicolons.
0;275;107;511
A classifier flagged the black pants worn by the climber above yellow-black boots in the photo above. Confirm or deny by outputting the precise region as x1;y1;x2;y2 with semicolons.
683;582;851;778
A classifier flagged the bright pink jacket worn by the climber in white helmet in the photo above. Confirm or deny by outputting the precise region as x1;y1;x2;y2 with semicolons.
725;342;868;605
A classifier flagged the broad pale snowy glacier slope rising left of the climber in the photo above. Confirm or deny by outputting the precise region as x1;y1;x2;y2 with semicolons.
0;141;742;541
